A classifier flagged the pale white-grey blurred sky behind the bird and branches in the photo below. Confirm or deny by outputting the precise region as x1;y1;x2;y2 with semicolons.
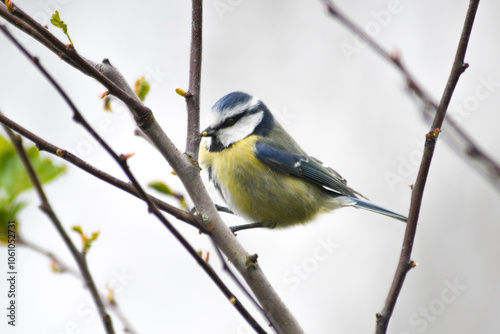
0;0;500;334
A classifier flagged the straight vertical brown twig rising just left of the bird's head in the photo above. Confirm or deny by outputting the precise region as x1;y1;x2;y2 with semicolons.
186;0;203;160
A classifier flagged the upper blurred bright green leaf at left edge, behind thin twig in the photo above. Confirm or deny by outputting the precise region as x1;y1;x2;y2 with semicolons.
0;136;66;202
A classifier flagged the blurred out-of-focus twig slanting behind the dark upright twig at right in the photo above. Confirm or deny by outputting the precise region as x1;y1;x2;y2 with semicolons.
322;0;500;192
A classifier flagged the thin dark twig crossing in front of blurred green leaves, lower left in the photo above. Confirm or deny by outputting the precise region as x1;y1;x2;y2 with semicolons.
1;121;115;334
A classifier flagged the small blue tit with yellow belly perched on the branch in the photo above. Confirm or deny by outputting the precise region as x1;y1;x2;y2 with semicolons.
199;92;407;232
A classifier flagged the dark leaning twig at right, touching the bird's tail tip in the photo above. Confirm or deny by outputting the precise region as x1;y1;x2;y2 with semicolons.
376;0;479;334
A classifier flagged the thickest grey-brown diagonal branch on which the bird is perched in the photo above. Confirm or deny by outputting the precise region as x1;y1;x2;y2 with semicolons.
0;3;302;333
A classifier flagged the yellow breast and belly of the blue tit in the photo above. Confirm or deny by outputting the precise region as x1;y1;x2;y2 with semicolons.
199;135;329;227
